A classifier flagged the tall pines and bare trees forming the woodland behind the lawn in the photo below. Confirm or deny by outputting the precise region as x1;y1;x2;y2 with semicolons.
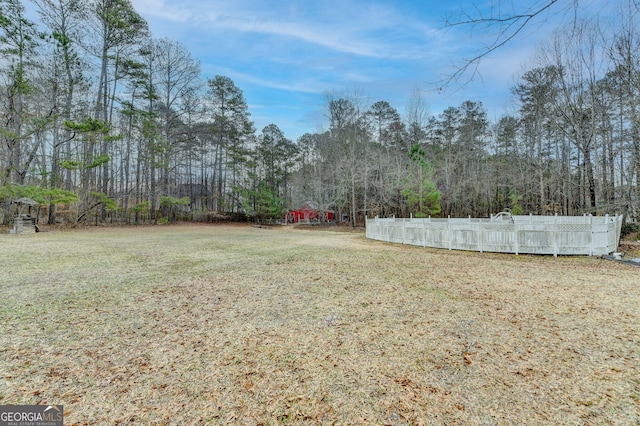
0;0;640;224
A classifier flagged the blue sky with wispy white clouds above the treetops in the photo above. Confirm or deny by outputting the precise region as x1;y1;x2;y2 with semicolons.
126;0;600;141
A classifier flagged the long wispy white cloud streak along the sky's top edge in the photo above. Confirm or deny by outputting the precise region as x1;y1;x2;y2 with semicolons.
134;0;443;59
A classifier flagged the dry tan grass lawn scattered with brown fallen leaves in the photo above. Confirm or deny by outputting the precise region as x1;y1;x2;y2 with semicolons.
0;225;640;425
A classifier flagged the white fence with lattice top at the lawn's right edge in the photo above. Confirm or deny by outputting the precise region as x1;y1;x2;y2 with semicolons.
366;213;622;256
